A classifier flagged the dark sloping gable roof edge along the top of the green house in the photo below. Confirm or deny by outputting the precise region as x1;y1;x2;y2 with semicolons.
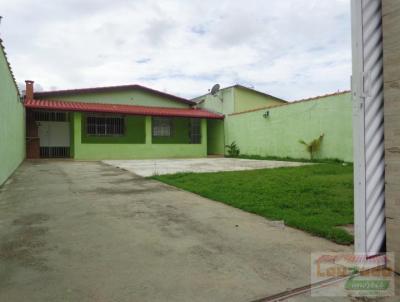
34;84;196;105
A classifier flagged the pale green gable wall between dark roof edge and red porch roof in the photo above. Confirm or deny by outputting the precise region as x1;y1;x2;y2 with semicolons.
39;90;190;108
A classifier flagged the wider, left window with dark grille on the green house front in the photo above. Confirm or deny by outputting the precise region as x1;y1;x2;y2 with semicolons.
86;115;125;136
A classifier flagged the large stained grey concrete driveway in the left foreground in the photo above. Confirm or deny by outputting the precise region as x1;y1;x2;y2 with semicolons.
0;161;351;302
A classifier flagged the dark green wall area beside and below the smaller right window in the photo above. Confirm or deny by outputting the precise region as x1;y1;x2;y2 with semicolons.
152;118;190;144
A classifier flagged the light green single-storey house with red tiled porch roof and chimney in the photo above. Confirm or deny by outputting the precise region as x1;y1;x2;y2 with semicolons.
25;81;224;160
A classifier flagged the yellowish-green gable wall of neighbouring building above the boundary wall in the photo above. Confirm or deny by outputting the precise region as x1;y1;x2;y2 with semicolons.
234;87;283;112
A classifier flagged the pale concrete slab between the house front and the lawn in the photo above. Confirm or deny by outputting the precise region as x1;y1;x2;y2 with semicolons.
103;158;308;177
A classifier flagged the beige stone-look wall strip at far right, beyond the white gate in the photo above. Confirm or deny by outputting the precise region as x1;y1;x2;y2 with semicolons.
382;0;400;273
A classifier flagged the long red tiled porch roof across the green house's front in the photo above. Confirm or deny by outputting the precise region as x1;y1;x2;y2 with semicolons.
25;100;224;119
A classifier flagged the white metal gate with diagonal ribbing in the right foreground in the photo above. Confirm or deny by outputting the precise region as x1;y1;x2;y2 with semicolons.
351;0;385;256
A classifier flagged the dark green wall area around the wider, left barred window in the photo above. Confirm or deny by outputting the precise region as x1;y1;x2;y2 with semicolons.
81;113;146;144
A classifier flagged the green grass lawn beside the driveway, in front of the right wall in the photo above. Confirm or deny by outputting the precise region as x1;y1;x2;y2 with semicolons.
152;163;353;244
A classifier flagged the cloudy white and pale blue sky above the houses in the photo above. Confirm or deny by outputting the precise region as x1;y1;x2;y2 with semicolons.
0;0;351;100
